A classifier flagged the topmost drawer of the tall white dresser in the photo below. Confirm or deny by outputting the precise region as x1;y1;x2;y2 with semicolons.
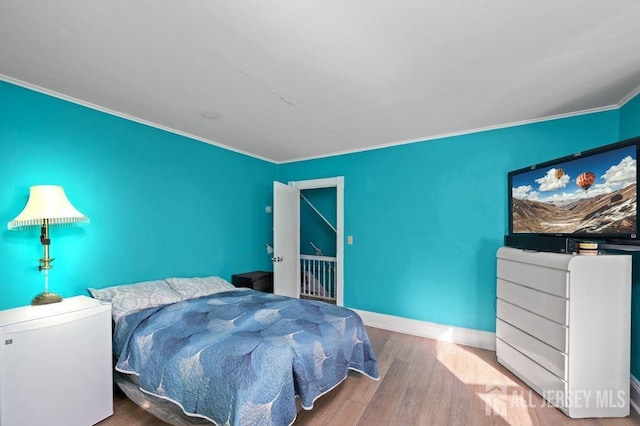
498;259;569;298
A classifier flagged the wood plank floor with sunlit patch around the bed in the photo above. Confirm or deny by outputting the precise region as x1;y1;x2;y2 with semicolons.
99;327;640;426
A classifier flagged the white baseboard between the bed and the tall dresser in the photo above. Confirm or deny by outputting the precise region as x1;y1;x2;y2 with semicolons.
352;309;496;351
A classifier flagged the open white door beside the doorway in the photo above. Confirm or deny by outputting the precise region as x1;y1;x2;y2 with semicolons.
272;182;300;298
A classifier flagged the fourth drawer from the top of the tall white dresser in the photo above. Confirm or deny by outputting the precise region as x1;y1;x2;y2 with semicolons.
496;320;569;380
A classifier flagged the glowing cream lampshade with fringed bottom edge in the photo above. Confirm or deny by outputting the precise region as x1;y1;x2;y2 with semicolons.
7;185;89;229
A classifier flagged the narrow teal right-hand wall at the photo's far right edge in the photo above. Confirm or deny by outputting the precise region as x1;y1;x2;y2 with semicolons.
620;95;640;377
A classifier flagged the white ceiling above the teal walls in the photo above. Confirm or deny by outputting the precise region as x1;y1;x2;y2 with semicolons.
0;0;640;162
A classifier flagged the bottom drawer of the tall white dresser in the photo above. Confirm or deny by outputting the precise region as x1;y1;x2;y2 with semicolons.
496;339;568;407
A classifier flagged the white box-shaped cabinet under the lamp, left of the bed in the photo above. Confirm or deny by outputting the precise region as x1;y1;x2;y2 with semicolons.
0;296;113;426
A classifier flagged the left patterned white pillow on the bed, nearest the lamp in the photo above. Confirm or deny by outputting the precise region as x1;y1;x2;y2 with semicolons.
89;280;182;321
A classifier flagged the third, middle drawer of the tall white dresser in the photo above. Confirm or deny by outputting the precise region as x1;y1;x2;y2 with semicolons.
497;299;569;353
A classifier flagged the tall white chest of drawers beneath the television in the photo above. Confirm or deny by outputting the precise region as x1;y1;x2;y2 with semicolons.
496;247;631;417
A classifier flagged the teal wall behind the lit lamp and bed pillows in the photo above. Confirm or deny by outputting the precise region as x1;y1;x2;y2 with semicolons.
0;82;277;309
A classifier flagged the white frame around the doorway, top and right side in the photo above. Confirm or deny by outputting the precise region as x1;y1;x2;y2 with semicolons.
288;176;344;306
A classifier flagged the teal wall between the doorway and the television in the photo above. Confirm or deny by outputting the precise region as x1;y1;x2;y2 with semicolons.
278;111;618;331
